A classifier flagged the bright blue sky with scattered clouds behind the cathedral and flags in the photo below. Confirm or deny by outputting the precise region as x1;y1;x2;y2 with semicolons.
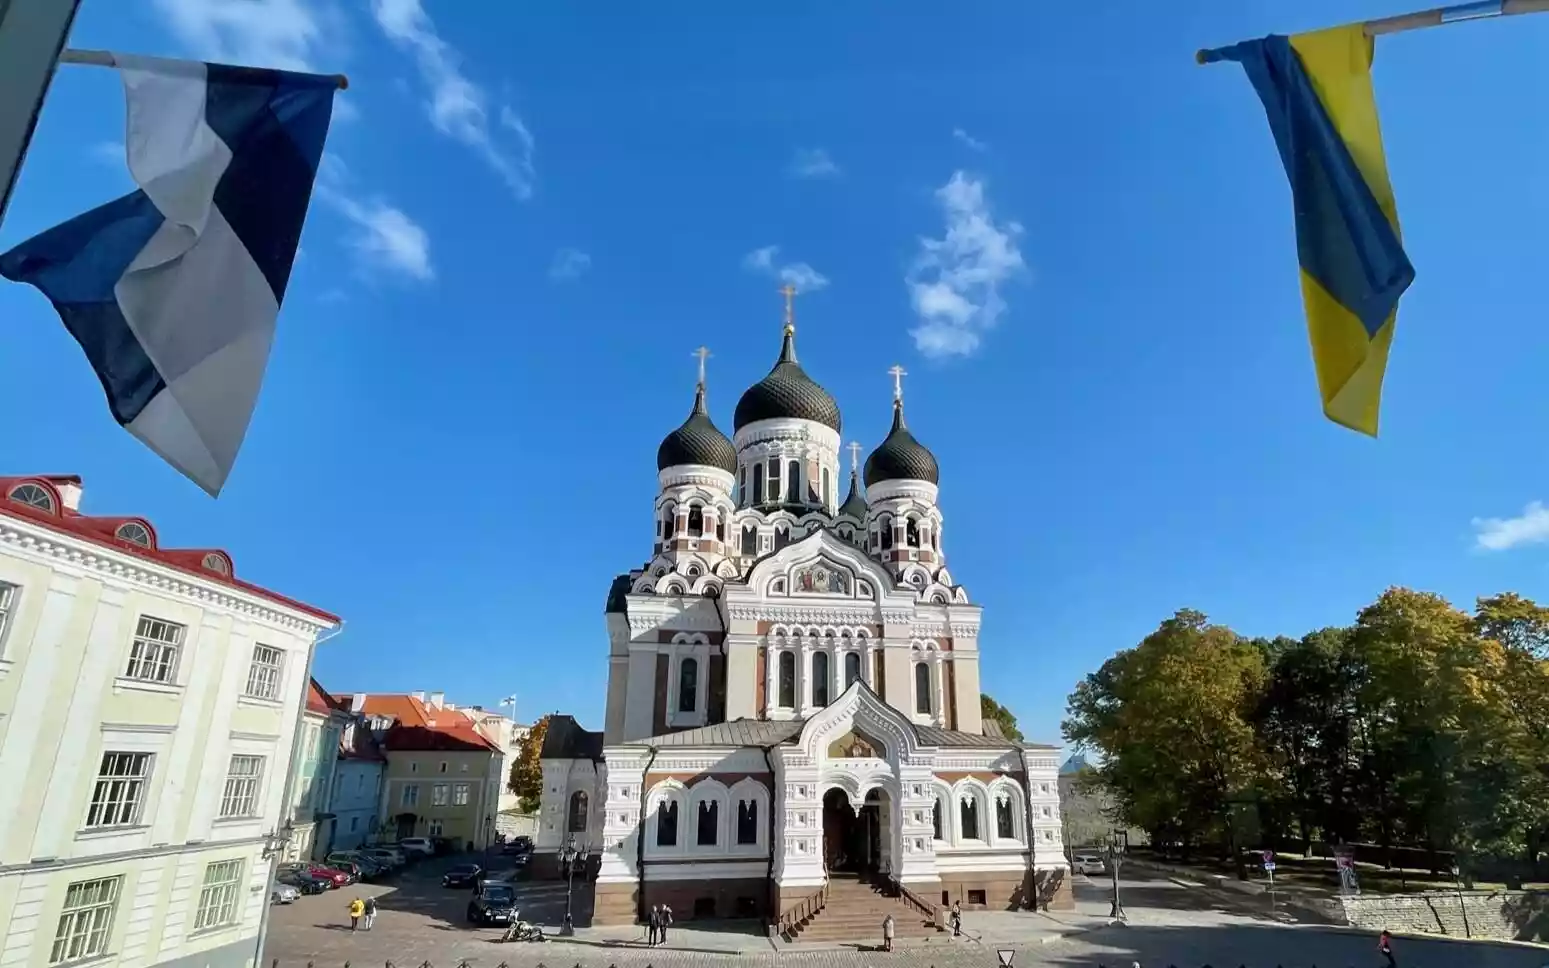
0;0;1549;740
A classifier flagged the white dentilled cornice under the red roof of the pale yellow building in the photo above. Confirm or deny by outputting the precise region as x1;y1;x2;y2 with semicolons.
0;517;333;637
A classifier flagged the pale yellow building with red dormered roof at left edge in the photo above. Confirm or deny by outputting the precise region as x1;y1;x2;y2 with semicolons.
0;475;339;968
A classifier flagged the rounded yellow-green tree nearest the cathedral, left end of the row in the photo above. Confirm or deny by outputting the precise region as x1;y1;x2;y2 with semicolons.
1064;609;1266;847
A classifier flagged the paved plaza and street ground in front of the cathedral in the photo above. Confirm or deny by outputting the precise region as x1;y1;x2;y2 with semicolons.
265;860;1549;968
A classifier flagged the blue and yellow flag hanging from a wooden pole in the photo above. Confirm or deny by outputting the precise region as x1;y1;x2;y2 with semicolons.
1200;23;1414;437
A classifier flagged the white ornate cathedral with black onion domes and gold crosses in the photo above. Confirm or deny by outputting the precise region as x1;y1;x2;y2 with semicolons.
534;291;1070;925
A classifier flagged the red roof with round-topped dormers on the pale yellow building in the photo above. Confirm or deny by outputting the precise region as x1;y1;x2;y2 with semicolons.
0;474;339;624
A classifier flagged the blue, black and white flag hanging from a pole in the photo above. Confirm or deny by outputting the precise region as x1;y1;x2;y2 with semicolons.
0;54;338;496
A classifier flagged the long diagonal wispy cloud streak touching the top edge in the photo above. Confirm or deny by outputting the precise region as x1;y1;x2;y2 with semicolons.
372;0;536;200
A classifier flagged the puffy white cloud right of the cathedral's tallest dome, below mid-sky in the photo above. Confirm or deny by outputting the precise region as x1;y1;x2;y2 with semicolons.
905;172;1024;356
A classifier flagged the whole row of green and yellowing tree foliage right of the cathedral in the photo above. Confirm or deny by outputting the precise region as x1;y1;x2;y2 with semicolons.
1064;589;1549;880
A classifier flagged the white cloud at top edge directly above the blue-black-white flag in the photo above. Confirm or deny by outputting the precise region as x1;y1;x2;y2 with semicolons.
153;0;356;121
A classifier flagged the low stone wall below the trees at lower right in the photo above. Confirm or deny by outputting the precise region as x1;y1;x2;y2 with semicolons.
1337;891;1549;942
